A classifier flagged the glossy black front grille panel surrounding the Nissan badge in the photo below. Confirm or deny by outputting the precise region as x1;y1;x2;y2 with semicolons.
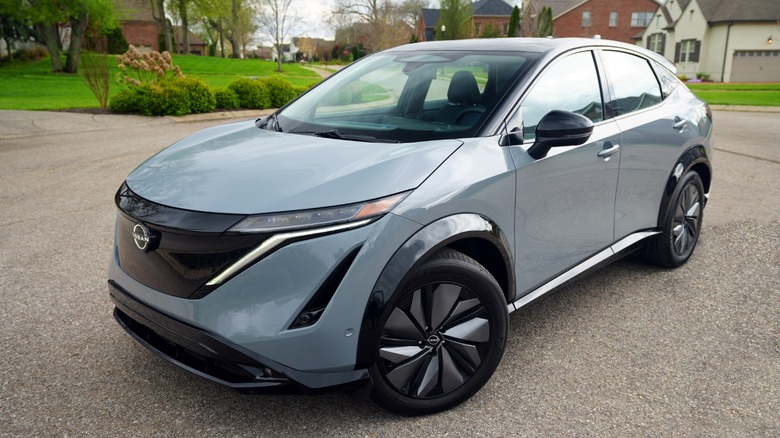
116;186;268;298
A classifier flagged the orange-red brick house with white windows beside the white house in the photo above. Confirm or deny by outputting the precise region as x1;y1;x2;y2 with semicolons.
523;0;659;44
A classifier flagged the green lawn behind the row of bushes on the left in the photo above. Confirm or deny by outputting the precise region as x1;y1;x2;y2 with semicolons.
0;55;320;110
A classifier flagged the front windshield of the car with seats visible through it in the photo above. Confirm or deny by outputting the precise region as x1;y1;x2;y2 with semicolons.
269;51;533;142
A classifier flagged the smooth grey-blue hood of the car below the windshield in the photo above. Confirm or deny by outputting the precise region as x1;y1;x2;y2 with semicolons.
127;121;462;214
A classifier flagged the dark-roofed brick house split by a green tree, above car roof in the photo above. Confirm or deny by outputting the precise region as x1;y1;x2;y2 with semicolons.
415;0;513;41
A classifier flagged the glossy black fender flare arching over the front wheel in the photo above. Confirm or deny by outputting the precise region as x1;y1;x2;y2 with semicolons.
355;213;515;369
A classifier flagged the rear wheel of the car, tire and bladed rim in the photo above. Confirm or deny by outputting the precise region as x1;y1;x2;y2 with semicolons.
648;171;704;268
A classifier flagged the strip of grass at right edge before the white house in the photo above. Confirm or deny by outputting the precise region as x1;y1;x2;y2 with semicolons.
686;82;780;106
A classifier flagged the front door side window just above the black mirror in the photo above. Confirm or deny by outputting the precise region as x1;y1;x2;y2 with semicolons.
521;52;604;139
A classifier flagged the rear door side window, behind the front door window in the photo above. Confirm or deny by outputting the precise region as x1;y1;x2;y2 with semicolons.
604;51;661;116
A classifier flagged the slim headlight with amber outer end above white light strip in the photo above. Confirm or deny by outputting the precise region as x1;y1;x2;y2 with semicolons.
228;192;409;233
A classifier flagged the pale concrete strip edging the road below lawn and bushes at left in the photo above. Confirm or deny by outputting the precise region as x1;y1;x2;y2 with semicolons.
0;109;274;141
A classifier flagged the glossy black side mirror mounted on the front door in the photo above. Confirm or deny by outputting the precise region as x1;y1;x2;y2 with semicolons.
528;110;593;160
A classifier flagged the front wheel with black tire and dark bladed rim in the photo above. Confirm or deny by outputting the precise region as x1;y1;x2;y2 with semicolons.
369;249;508;415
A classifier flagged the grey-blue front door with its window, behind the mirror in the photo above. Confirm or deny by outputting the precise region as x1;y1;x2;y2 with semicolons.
507;51;621;296
